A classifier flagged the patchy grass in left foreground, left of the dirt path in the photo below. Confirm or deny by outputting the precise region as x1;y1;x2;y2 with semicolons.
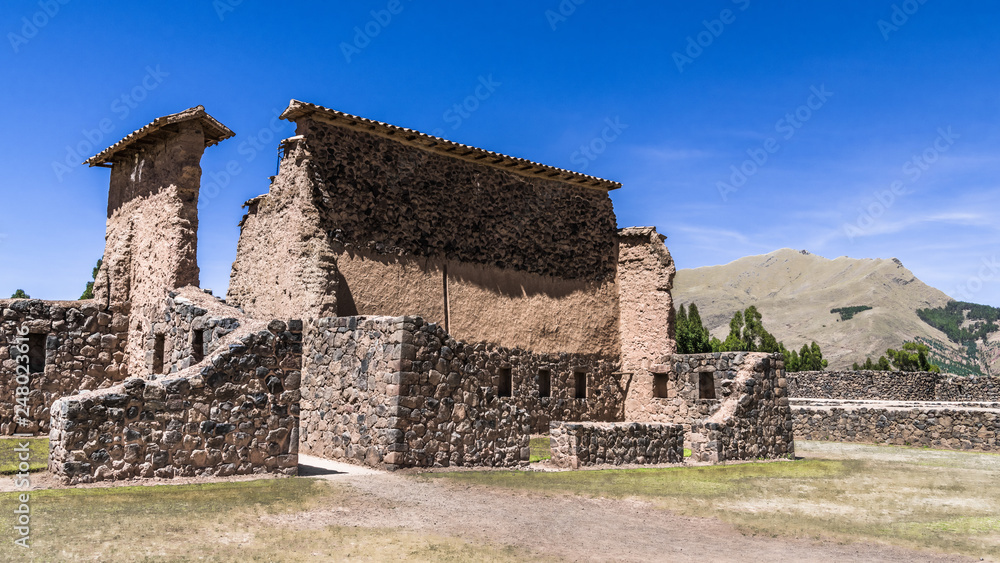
0;479;536;562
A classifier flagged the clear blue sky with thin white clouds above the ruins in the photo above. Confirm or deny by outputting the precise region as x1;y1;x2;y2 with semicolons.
0;0;1000;306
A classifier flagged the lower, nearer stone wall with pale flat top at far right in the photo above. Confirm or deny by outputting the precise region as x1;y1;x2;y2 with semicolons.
794;406;1000;452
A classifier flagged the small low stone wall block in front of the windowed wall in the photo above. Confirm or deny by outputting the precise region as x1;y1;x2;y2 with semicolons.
549;422;684;469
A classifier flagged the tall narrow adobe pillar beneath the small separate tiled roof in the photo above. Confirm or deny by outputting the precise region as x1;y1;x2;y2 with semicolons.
94;121;205;375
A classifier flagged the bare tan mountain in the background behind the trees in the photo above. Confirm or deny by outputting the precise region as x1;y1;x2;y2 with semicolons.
673;248;1000;373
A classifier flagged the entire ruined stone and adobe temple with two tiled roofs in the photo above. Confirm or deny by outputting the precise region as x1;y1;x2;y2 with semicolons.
0;101;793;483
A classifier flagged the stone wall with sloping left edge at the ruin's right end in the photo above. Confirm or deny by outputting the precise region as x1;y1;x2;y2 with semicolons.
689;352;795;463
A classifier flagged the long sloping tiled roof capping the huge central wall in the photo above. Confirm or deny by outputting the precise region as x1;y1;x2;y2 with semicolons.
281;100;622;191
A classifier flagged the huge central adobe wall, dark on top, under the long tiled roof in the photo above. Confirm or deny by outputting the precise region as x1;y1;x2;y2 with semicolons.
228;118;620;357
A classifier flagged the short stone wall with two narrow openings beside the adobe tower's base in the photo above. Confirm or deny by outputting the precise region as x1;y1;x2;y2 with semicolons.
145;287;244;375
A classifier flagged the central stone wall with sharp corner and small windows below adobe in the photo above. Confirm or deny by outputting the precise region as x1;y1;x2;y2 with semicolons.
302;317;625;467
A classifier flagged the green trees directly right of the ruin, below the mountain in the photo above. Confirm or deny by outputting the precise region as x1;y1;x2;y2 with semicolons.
674;303;828;372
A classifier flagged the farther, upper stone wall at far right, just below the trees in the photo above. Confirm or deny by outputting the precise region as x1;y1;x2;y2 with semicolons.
788;371;1000;402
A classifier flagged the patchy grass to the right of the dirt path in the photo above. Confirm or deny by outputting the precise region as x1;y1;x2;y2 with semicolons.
423;443;1000;559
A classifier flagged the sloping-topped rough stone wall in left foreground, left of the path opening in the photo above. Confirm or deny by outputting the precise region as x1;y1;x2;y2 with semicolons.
49;321;302;484
